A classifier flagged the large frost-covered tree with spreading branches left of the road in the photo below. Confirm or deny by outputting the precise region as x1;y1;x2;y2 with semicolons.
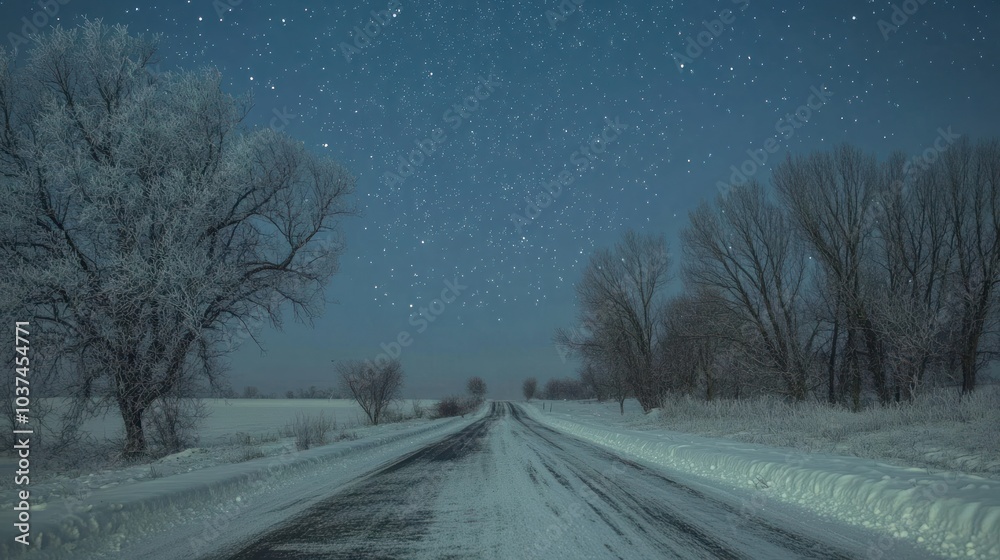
0;21;356;457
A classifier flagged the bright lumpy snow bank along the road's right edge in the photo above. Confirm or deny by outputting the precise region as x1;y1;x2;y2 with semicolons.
529;407;1000;560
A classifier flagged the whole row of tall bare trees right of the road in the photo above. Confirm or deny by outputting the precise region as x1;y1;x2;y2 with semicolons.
555;138;1000;410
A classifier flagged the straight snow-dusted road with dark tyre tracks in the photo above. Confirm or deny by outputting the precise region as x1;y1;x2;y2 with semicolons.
205;403;924;560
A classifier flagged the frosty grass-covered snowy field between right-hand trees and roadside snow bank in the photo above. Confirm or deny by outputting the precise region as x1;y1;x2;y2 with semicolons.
538;385;1000;480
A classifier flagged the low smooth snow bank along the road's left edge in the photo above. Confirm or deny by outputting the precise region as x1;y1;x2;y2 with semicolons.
0;412;482;558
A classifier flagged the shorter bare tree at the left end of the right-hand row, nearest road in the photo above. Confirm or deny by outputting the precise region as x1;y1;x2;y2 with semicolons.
555;231;668;412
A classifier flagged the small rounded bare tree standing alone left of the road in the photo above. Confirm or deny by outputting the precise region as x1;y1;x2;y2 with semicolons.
337;360;403;426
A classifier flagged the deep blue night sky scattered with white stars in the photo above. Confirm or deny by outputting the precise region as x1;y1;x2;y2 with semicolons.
0;0;1000;398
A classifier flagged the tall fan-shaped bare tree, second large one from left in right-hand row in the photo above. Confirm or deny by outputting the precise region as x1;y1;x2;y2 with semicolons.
682;182;817;400
